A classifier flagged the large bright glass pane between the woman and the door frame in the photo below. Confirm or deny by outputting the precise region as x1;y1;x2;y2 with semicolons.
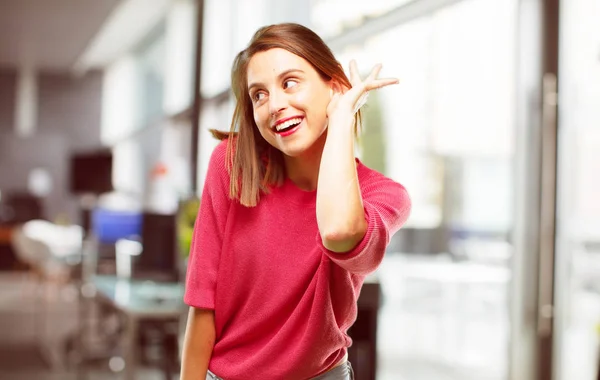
328;0;517;380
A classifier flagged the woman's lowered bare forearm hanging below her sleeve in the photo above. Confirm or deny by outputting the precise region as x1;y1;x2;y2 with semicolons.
181;307;215;380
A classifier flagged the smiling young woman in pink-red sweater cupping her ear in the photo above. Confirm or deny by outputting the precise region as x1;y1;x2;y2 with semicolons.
182;24;410;380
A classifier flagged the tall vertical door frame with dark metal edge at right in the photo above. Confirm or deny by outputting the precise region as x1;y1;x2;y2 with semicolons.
509;0;559;380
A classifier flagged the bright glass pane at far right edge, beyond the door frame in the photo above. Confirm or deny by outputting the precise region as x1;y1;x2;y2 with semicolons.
554;0;600;380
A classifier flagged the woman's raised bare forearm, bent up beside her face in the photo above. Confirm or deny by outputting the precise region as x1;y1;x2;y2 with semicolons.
317;115;367;252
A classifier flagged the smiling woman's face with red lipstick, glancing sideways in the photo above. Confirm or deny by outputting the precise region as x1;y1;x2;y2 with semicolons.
248;48;331;157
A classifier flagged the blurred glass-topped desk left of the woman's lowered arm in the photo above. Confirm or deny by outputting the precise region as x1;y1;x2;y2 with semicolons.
90;276;188;380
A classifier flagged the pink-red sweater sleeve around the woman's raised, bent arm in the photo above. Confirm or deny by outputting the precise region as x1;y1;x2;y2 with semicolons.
317;173;411;275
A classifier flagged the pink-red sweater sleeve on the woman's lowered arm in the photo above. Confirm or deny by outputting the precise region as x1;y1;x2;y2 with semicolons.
184;140;232;309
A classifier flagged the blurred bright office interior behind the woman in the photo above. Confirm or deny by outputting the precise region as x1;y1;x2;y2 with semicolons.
0;0;600;380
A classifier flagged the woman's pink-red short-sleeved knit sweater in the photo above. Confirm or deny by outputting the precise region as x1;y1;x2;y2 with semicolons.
185;141;410;380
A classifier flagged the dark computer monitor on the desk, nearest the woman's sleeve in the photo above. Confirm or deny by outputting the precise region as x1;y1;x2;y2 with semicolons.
132;212;179;281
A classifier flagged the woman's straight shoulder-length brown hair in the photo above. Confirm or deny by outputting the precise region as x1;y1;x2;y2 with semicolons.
211;23;360;207
